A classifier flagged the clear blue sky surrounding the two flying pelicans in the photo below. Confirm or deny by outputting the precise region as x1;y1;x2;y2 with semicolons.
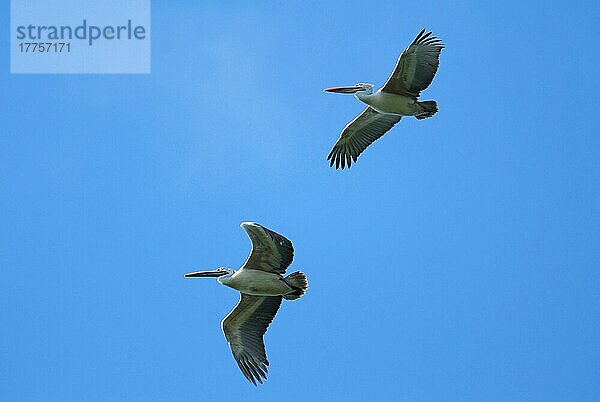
0;1;600;401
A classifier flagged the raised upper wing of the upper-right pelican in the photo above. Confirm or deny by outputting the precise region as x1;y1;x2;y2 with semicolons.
381;29;444;99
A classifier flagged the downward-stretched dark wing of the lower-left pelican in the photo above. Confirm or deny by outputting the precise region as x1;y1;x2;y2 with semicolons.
221;293;281;385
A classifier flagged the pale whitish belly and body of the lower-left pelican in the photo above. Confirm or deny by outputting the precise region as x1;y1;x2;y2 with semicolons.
222;269;292;296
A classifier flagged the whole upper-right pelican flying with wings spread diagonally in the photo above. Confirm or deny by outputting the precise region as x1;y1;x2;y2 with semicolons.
324;29;444;169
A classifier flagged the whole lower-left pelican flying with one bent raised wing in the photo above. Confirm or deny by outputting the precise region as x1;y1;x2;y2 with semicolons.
184;222;308;385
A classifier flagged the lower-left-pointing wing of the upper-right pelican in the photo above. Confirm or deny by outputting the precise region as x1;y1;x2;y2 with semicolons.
327;107;401;169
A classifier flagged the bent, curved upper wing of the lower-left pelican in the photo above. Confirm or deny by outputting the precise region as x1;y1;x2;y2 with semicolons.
240;222;294;275
